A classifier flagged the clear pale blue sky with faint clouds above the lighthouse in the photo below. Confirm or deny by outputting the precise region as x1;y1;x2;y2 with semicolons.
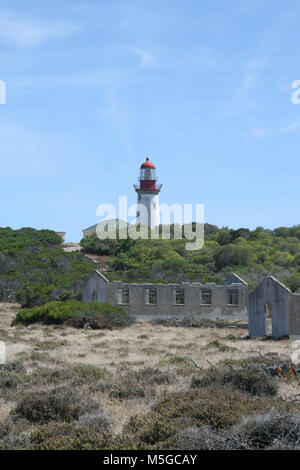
0;0;300;241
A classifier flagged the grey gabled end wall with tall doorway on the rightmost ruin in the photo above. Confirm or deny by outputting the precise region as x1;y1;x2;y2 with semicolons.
248;276;293;338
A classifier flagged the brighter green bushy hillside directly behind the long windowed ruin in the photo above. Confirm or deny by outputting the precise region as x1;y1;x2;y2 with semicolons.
80;224;300;291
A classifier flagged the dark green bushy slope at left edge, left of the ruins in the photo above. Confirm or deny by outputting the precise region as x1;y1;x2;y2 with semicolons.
0;228;94;307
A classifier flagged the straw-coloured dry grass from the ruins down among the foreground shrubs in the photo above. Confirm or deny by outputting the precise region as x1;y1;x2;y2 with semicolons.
0;304;299;450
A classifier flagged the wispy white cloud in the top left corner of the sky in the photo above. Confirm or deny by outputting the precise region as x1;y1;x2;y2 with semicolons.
0;10;80;48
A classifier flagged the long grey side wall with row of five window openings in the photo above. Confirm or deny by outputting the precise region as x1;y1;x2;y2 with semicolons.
107;281;248;319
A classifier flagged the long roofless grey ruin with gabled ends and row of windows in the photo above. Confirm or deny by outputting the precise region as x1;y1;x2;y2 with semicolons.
83;270;248;320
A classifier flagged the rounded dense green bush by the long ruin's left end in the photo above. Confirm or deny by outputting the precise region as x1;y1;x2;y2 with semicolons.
14;300;129;329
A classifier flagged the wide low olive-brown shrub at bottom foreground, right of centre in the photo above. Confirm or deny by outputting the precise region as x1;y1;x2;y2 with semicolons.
125;385;270;449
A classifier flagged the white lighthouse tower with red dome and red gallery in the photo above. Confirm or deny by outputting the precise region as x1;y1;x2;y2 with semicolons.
133;157;162;229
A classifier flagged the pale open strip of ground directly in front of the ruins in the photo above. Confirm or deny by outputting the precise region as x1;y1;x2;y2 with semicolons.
0;303;292;367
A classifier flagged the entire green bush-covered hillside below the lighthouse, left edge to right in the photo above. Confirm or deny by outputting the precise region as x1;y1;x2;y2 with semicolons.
0;224;300;307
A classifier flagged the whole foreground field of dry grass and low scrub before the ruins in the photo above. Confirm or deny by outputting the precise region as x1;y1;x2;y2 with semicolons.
0;300;300;450
